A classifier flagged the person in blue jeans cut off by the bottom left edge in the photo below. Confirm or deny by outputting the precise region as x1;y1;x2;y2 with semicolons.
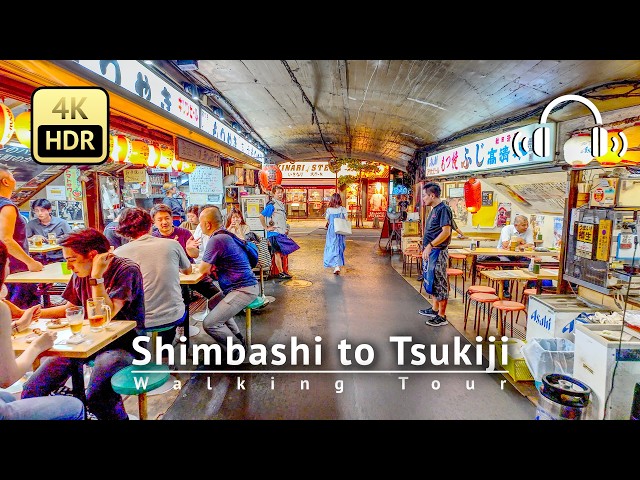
0;242;84;420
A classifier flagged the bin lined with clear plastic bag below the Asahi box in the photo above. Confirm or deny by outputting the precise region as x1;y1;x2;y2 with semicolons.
522;338;575;390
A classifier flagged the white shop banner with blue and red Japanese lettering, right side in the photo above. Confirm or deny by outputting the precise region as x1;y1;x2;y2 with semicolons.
425;123;556;177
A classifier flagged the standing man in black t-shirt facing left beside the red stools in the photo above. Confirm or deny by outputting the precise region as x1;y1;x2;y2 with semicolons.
418;182;453;327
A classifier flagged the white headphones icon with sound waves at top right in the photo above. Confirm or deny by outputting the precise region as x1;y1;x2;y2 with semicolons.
532;95;627;157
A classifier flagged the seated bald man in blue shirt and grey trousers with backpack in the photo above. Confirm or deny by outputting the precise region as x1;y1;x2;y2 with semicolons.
199;206;260;360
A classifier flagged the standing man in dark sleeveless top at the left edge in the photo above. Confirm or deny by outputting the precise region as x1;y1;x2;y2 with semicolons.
0;165;44;308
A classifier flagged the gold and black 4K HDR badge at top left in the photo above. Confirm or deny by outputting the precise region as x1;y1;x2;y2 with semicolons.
31;87;109;165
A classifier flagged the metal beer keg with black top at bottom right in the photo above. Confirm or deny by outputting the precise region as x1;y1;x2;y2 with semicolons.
536;373;591;420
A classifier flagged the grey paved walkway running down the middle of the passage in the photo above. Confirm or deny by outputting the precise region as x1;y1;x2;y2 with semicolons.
160;221;535;420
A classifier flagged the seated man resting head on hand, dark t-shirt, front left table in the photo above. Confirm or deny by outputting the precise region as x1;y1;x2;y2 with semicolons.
22;228;145;420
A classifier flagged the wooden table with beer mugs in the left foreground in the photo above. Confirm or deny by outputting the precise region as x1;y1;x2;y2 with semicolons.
11;318;136;404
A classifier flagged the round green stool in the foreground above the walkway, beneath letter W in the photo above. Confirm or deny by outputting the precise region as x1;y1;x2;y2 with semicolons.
111;363;171;420
